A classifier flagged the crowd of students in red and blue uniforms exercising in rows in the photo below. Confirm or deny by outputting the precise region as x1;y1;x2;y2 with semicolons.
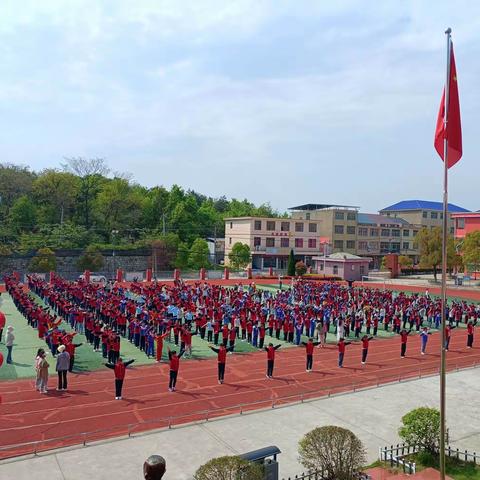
1;276;480;397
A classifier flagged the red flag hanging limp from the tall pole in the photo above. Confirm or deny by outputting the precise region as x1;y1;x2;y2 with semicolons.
434;44;462;168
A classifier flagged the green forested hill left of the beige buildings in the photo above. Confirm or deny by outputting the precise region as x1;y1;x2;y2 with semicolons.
0;158;279;255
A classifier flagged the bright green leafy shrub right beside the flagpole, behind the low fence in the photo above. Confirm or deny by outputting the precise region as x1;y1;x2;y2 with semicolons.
398;407;440;453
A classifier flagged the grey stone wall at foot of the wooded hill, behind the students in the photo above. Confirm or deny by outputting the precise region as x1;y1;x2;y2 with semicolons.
0;250;151;279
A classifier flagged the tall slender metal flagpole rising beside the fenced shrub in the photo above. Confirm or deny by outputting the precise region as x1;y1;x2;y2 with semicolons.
439;28;452;480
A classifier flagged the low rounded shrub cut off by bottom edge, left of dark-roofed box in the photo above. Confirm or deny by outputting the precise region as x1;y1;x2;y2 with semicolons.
193;456;264;480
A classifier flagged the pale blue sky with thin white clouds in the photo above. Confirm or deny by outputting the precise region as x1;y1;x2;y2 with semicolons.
0;0;480;212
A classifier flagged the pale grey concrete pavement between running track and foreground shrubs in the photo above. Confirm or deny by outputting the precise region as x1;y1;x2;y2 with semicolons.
0;369;480;480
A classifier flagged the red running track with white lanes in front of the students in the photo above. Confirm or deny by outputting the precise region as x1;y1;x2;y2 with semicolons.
0;330;480;458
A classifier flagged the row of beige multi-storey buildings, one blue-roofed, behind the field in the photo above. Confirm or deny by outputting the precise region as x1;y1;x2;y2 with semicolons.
225;200;468;270
